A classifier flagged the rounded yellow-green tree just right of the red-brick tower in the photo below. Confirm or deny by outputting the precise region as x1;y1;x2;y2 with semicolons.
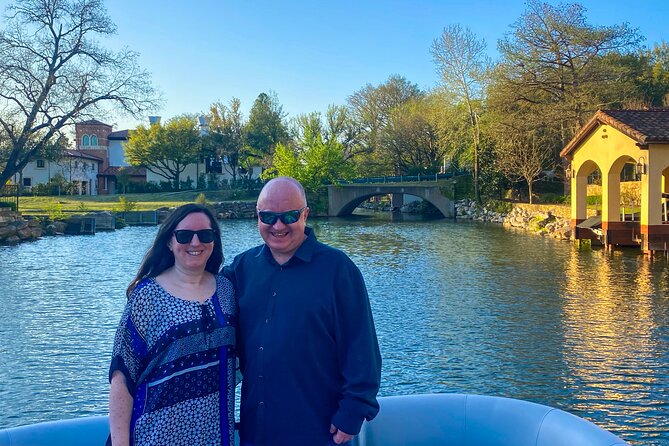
125;116;202;190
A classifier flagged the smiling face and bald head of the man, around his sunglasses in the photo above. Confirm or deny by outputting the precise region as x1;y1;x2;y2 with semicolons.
257;183;309;263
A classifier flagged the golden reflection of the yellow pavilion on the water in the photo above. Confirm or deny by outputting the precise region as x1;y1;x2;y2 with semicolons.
563;250;669;444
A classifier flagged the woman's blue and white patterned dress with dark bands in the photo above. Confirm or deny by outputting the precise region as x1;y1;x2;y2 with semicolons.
109;276;236;446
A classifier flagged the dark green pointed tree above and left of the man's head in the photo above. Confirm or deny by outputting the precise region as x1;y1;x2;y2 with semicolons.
244;93;289;166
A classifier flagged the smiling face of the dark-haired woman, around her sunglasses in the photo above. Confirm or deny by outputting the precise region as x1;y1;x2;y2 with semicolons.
169;212;216;272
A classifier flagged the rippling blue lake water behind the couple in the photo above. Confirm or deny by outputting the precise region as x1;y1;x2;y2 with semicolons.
0;218;669;446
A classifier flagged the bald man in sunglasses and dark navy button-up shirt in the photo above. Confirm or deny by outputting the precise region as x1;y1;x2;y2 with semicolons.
224;177;381;446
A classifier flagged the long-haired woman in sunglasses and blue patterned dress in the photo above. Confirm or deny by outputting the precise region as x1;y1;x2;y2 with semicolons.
109;204;236;446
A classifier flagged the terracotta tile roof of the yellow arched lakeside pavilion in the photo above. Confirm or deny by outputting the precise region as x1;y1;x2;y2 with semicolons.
560;108;669;157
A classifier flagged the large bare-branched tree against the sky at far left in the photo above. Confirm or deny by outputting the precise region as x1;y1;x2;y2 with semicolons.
0;0;156;184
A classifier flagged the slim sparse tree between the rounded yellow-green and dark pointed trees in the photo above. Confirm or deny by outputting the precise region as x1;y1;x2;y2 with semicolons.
204;98;248;183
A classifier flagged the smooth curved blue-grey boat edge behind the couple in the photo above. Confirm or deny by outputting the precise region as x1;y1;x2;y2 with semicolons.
0;394;629;446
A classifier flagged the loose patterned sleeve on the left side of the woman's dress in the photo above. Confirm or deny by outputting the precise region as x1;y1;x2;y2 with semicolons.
109;292;148;397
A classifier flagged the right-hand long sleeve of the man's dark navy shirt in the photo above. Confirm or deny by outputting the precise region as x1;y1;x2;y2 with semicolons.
332;254;381;435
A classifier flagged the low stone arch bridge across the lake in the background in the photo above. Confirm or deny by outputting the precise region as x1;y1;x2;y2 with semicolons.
328;182;455;218
